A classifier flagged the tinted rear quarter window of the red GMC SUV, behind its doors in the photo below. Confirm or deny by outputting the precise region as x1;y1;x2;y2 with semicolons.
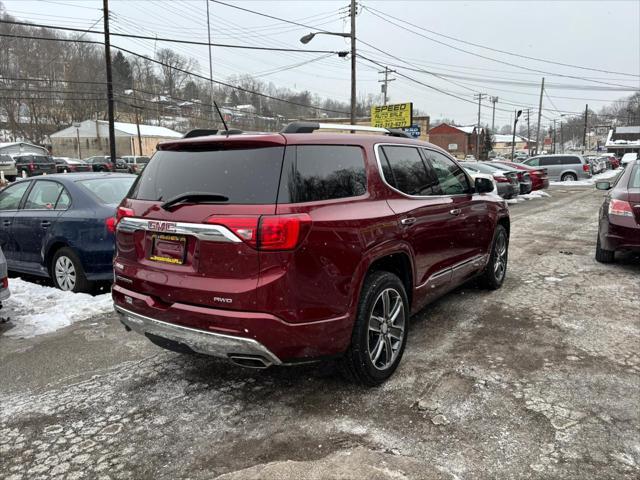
289;145;367;202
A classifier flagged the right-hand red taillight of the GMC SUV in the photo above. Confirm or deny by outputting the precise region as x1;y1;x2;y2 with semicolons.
205;214;311;250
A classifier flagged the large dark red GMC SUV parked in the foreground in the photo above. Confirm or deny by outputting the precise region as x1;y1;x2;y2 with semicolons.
113;122;509;385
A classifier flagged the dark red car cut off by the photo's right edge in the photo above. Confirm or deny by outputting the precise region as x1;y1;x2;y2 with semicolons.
596;160;640;263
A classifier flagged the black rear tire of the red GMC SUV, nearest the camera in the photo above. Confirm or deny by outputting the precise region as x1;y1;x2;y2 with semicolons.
340;271;409;386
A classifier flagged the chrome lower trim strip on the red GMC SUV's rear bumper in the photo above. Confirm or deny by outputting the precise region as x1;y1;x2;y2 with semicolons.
115;305;282;367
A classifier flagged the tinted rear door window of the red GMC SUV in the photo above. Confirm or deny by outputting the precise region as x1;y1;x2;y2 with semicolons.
380;146;438;195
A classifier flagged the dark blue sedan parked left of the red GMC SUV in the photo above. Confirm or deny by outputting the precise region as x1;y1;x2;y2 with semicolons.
0;173;137;292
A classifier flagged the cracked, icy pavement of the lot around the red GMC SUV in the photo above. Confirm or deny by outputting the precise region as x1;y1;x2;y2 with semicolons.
0;187;640;480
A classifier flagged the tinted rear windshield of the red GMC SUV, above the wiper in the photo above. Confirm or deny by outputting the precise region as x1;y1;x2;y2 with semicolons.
131;147;284;204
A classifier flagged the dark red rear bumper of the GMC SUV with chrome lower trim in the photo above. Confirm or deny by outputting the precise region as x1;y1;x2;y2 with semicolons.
111;281;353;364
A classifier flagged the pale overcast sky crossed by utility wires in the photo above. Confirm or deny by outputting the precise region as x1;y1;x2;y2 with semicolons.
2;0;640;129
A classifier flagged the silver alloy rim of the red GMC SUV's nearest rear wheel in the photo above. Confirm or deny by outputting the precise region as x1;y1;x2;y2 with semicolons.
367;288;405;370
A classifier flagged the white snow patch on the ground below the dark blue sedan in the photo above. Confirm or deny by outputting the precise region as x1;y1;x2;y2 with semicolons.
1;278;113;338
